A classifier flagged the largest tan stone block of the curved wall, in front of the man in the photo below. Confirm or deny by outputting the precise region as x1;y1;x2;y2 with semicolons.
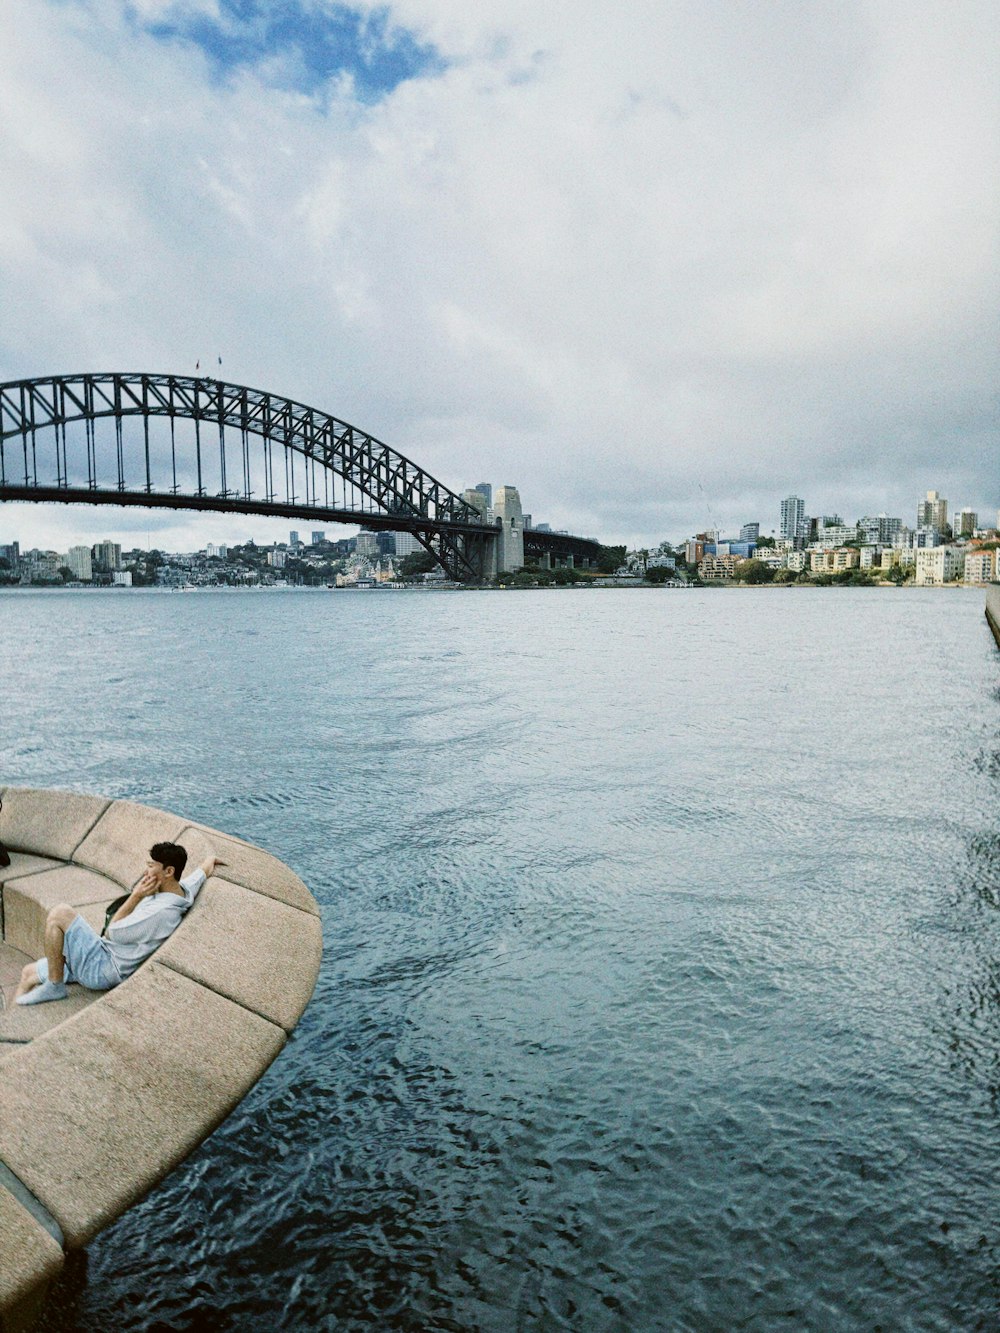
0;960;285;1246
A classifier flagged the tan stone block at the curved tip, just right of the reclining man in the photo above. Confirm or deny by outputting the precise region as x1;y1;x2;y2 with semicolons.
156;876;323;1032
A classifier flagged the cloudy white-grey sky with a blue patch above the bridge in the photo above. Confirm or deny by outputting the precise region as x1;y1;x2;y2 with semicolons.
0;0;1000;549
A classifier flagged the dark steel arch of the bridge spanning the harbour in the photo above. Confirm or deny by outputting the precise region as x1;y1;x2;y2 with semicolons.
0;371;501;581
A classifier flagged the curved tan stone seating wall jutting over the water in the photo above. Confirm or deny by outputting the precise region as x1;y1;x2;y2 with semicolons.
0;786;321;1333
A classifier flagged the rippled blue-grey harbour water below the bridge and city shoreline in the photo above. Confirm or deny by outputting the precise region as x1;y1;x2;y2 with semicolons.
0;588;1000;1333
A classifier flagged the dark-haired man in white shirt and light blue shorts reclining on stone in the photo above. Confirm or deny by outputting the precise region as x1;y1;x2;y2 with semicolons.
17;842;225;1004
